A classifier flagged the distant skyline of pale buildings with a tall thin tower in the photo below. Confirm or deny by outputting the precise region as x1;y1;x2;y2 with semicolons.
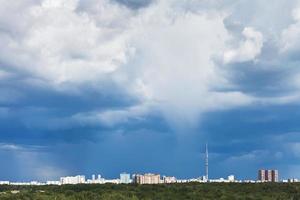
0;144;300;185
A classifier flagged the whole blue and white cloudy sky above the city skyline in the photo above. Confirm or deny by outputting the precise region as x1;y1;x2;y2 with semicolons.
0;0;300;181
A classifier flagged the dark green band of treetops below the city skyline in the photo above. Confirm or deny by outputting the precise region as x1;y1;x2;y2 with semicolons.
0;183;300;200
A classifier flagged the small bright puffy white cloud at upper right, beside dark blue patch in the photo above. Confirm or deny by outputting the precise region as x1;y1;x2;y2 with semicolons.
223;27;263;63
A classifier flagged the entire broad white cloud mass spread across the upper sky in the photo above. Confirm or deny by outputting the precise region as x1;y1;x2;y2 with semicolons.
4;0;299;130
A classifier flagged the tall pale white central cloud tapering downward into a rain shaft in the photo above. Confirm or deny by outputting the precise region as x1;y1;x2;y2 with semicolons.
115;2;255;124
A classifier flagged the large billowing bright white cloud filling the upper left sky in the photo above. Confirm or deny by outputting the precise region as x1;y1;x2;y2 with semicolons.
1;0;132;84
